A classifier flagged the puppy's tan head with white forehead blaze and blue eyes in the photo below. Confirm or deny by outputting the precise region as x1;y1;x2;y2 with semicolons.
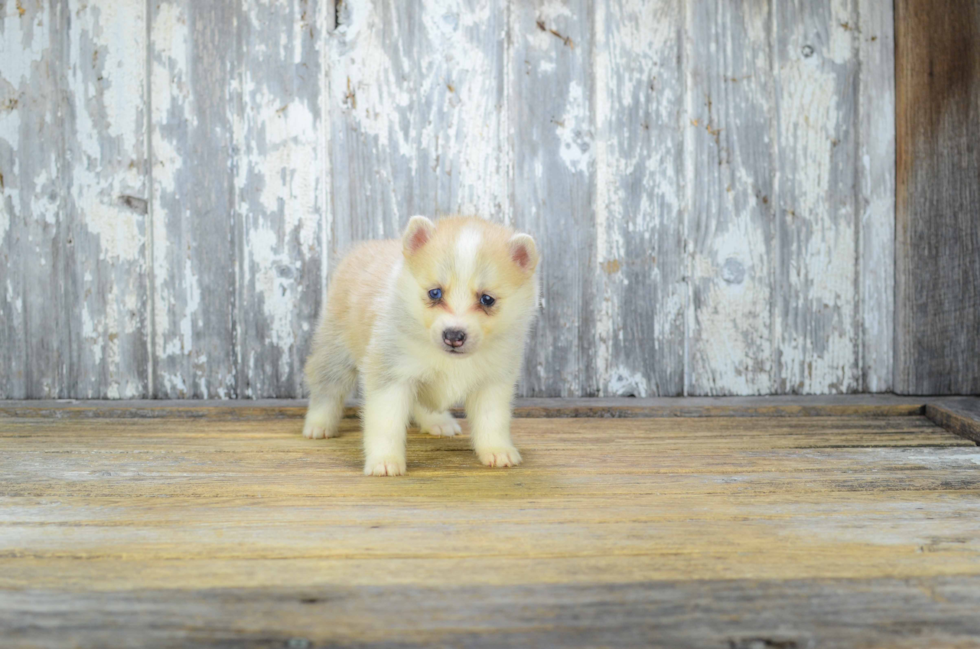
402;216;538;358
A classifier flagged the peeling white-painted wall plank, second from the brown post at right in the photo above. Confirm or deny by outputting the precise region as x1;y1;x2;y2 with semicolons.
774;0;860;393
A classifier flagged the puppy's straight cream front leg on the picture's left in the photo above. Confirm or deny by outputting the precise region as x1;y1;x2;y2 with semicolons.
364;381;414;476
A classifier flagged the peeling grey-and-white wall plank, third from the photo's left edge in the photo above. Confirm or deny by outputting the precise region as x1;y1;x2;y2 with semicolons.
150;0;243;398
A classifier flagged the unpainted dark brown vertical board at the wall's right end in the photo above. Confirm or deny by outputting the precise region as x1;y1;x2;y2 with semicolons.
895;0;980;394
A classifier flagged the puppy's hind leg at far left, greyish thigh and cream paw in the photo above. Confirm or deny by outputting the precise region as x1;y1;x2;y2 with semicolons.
303;326;357;439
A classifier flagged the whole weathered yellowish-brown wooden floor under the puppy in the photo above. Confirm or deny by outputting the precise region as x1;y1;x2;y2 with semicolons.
0;398;980;649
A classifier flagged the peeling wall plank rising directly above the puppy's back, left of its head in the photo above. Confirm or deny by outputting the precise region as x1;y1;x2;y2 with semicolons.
325;0;420;248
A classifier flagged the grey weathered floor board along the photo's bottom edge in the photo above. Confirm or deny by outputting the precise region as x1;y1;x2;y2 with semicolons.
0;577;980;649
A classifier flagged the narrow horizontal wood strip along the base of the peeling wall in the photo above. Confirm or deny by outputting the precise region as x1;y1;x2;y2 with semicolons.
0;395;927;419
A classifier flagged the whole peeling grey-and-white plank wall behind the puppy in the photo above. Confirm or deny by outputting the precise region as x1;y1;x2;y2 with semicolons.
0;0;895;398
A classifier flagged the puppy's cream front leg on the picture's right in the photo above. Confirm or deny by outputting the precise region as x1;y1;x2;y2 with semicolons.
466;383;521;466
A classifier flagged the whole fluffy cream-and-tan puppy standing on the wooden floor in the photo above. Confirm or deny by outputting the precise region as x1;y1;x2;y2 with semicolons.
303;216;538;476
